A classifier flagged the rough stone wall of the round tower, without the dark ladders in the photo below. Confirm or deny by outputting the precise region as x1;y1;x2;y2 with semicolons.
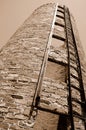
0;3;86;130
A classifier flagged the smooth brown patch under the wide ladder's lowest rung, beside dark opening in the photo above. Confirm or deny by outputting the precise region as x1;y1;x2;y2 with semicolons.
34;111;59;130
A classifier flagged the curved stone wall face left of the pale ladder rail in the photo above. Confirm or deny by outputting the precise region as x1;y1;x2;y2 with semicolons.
0;4;56;130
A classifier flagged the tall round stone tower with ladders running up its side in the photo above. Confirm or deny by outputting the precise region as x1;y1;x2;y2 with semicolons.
0;3;86;130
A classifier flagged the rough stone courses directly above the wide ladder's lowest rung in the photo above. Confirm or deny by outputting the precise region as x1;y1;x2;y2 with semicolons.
40;78;68;114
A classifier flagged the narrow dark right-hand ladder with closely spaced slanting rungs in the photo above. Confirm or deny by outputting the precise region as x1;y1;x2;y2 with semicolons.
64;7;86;130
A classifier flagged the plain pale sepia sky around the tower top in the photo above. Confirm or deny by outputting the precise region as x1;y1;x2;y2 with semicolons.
0;0;86;55
